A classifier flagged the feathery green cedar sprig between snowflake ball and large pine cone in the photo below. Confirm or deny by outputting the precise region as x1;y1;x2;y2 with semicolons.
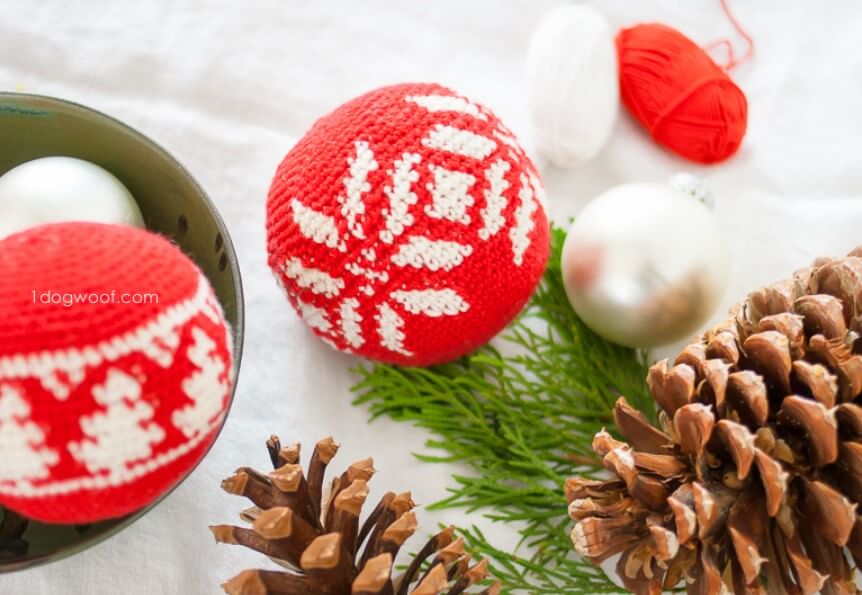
354;228;655;594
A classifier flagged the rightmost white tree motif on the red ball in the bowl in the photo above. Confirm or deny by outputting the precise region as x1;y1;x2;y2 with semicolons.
171;327;229;438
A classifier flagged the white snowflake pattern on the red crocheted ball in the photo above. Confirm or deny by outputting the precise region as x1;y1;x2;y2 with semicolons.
281;94;542;357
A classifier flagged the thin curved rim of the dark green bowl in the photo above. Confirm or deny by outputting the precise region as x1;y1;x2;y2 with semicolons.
0;91;245;575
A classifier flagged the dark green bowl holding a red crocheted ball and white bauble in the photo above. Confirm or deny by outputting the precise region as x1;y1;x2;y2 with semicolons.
0;93;243;573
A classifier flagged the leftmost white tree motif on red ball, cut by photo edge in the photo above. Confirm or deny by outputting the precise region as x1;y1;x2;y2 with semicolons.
0;385;59;483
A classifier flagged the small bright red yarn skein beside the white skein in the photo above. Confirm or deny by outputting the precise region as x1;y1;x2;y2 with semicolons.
617;23;748;163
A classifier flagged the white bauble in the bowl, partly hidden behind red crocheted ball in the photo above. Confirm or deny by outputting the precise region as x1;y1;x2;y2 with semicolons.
0;157;144;238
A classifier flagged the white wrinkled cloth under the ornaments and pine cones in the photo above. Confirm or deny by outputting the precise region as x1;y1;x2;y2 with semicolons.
0;0;862;595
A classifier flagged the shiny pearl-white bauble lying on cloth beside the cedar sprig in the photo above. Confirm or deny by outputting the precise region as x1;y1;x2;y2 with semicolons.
561;183;730;348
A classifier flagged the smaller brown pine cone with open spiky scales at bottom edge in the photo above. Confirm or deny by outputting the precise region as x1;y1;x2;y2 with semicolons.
210;436;500;595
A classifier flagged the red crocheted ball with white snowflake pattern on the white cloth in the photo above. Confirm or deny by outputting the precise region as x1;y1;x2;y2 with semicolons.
267;84;548;365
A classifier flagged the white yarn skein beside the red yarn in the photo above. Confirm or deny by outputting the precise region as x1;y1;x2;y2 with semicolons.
527;5;620;167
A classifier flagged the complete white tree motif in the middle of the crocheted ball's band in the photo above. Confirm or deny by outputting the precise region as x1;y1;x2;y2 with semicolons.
68;368;165;478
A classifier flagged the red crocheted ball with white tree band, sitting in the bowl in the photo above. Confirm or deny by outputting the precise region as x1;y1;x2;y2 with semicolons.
0;223;232;523
